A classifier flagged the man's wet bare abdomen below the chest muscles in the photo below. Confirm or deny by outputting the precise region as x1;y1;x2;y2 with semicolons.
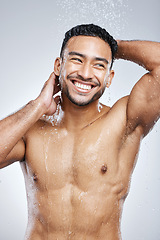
25;184;122;240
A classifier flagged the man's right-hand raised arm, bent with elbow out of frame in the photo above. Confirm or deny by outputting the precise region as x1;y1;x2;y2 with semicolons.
116;41;160;136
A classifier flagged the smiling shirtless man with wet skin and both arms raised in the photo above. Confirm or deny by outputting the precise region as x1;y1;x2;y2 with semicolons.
0;24;160;240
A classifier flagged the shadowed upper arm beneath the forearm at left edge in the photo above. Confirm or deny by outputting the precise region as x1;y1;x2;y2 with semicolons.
0;139;25;168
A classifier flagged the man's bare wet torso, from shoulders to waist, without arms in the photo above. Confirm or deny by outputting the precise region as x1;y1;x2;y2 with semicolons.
21;96;141;240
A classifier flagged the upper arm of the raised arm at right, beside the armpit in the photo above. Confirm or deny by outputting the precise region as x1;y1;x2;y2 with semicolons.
127;68;160;136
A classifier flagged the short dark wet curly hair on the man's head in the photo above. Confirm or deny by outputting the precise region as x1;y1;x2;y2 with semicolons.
60;24;118;68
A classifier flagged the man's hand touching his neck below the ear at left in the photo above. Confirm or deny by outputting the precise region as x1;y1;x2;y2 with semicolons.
37;72;60;115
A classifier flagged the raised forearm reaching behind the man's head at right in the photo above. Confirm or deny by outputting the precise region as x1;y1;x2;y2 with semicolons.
116;40;160;71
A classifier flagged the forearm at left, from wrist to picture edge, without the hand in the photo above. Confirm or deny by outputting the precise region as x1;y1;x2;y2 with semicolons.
0;99;43;161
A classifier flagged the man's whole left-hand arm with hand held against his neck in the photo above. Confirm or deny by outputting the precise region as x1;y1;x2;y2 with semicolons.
0;73;59;168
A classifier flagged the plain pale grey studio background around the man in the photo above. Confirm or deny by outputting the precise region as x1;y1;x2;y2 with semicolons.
0;0;160;240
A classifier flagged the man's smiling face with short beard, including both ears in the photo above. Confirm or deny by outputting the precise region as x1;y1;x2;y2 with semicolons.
55;36;114;106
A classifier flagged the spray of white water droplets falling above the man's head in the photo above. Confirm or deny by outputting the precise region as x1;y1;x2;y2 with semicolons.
57;0;129;35
